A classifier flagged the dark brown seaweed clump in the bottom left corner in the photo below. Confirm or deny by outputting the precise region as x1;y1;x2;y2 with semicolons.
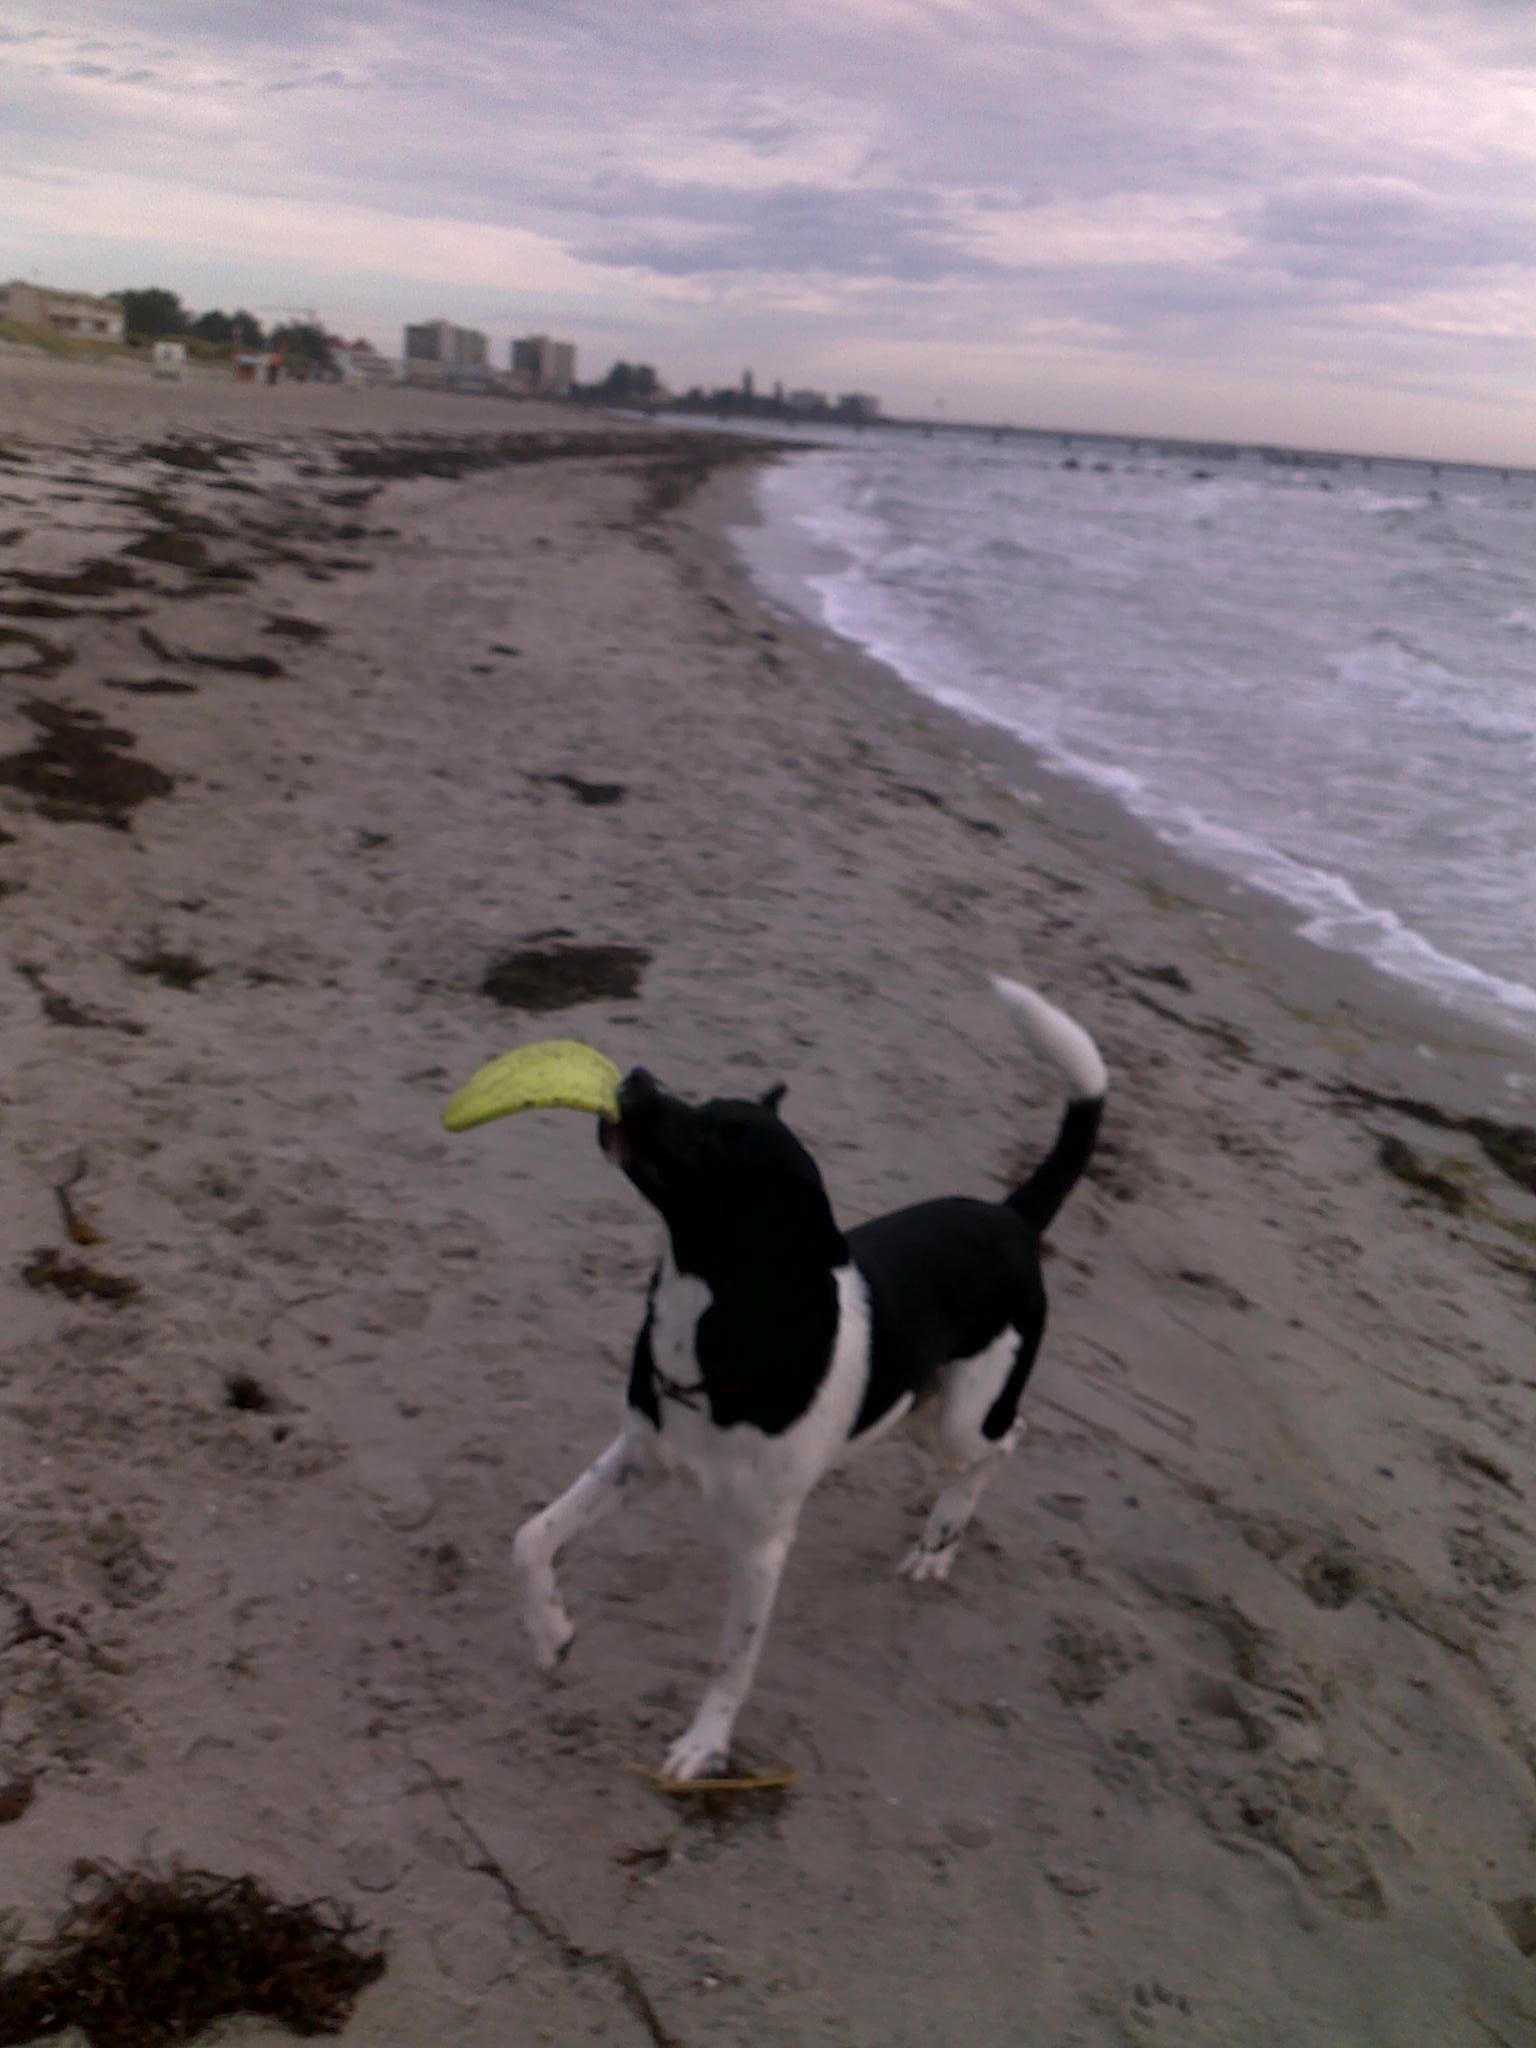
0;1862;385;2048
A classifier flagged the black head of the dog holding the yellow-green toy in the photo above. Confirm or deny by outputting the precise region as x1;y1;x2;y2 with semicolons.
600;1067;848;1278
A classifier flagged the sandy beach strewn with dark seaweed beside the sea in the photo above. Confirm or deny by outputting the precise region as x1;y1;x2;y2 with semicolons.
0;352;1536;2048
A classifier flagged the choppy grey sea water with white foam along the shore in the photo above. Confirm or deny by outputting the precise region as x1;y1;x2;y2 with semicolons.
739;430;1536;1042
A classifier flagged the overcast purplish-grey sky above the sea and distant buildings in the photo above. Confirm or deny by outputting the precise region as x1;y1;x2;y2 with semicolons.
0;0;1536;463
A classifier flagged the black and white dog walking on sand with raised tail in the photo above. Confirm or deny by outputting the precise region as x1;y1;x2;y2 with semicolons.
512;981;1106;1780
